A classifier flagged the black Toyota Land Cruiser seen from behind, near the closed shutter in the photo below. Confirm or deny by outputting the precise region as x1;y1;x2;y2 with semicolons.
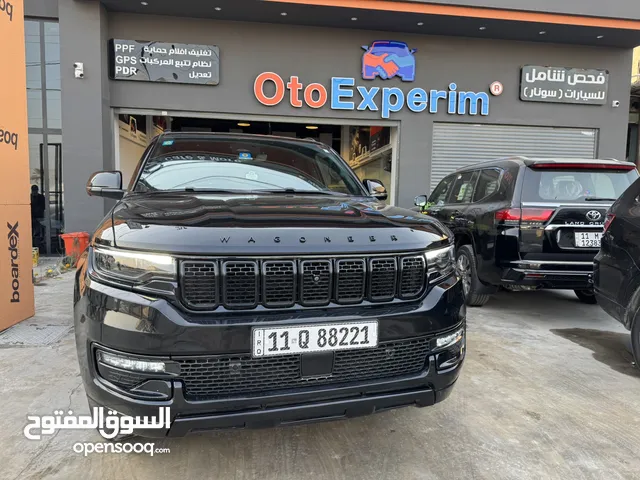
416;157;638;306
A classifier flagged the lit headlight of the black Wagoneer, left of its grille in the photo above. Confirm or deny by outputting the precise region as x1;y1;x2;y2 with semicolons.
93;249;177;283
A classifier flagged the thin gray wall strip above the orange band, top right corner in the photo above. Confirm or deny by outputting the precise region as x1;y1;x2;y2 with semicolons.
397;0;640;20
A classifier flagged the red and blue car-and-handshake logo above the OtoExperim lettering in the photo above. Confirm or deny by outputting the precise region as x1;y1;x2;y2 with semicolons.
362;40;416;82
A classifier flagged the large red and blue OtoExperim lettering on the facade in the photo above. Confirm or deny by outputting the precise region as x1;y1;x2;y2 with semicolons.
253;72;489;118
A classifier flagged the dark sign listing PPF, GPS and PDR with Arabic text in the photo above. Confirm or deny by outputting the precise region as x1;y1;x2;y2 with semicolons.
109;39;220;85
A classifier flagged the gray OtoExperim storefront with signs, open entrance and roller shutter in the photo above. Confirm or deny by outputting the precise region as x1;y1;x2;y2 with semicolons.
22;0;640;236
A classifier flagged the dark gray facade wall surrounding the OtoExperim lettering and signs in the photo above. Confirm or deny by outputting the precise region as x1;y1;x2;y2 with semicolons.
60;9;632;230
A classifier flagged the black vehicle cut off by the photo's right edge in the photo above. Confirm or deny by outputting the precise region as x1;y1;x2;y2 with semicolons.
594;180;640;364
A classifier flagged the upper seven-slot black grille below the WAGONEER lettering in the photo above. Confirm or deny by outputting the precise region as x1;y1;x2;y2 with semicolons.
180;255;426;310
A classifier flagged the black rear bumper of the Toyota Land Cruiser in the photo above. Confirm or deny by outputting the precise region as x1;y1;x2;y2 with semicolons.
502;262;593;290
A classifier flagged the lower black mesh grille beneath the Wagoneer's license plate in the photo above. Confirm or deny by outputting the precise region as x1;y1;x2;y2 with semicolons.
176;337;429;400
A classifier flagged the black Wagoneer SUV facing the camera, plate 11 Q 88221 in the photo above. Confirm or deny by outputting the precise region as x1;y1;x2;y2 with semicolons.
74;133;466;436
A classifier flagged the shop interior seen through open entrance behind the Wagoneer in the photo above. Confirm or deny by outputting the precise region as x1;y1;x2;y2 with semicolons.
117;114;394;203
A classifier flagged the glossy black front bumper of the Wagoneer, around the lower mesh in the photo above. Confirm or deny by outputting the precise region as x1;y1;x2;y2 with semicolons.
74;268;466;436
